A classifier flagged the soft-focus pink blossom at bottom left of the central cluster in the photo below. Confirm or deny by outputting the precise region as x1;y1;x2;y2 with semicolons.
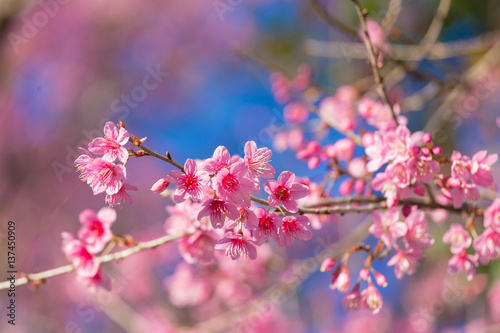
179;230;216;264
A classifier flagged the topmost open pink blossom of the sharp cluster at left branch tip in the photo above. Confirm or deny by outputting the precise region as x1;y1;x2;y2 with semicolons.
89;121;130;163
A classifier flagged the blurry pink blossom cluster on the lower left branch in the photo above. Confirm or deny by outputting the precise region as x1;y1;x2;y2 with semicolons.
62;207;116;290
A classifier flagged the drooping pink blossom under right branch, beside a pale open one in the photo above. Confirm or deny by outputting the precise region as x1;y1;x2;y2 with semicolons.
403;206;434;249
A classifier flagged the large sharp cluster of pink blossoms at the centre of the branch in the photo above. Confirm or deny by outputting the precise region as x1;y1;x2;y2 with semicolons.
160;141;312;263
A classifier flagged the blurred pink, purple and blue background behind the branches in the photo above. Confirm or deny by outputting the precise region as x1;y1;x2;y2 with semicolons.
0;0;500;333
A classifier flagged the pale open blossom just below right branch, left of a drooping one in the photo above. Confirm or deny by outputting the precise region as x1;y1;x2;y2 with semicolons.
369;207;408;246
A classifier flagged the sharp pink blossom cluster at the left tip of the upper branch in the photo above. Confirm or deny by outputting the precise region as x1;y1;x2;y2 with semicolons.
75;122;137;206
